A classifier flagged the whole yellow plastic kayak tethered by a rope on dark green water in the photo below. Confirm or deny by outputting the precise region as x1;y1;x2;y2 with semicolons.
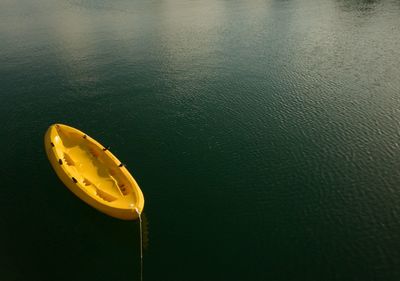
44;124;144;220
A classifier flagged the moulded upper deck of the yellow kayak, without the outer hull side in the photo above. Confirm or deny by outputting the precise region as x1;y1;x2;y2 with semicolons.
52;125;136;207
